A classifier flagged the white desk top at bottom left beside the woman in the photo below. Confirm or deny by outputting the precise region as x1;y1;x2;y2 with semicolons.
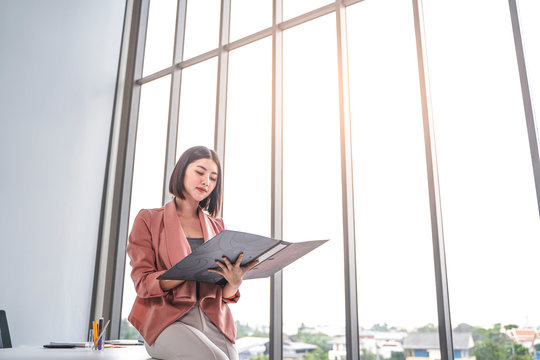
0;345;151;360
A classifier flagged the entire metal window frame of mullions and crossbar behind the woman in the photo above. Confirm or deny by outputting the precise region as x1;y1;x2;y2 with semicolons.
90;0;540;360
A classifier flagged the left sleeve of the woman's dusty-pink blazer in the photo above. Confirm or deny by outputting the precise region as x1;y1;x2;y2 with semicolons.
126;210;168;298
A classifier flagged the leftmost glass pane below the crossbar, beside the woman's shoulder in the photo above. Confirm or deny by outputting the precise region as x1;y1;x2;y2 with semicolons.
120;76;171;339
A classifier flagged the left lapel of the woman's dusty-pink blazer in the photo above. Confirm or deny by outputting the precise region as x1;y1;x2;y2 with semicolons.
163;199;191;268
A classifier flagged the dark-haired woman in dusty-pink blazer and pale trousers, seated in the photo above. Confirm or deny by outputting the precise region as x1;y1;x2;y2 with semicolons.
127;146;257;360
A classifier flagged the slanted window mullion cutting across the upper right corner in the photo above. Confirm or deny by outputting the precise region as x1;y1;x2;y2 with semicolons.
508;0;540;217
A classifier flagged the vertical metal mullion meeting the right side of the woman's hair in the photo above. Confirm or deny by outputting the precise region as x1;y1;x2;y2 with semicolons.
214;0;231;169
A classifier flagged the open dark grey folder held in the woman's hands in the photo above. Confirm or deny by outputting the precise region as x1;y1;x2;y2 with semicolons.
158;230;328;285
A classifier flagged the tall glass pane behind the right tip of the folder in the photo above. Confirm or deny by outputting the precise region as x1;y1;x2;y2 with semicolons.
283;14;345;357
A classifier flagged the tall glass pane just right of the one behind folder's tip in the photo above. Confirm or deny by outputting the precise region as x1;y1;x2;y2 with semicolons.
348;0;439;359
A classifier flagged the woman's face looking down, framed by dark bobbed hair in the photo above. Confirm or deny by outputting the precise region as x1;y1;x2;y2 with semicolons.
184;159;218;202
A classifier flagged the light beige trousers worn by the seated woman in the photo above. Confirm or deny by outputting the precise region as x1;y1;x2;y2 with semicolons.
145;304;238;360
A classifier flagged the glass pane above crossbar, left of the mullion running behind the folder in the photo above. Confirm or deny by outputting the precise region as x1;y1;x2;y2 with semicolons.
230;0;272;41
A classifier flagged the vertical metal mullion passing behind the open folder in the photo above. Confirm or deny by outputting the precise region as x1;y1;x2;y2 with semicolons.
269;0;283;360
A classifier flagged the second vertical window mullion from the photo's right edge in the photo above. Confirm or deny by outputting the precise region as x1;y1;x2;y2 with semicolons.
412;0;454;360
